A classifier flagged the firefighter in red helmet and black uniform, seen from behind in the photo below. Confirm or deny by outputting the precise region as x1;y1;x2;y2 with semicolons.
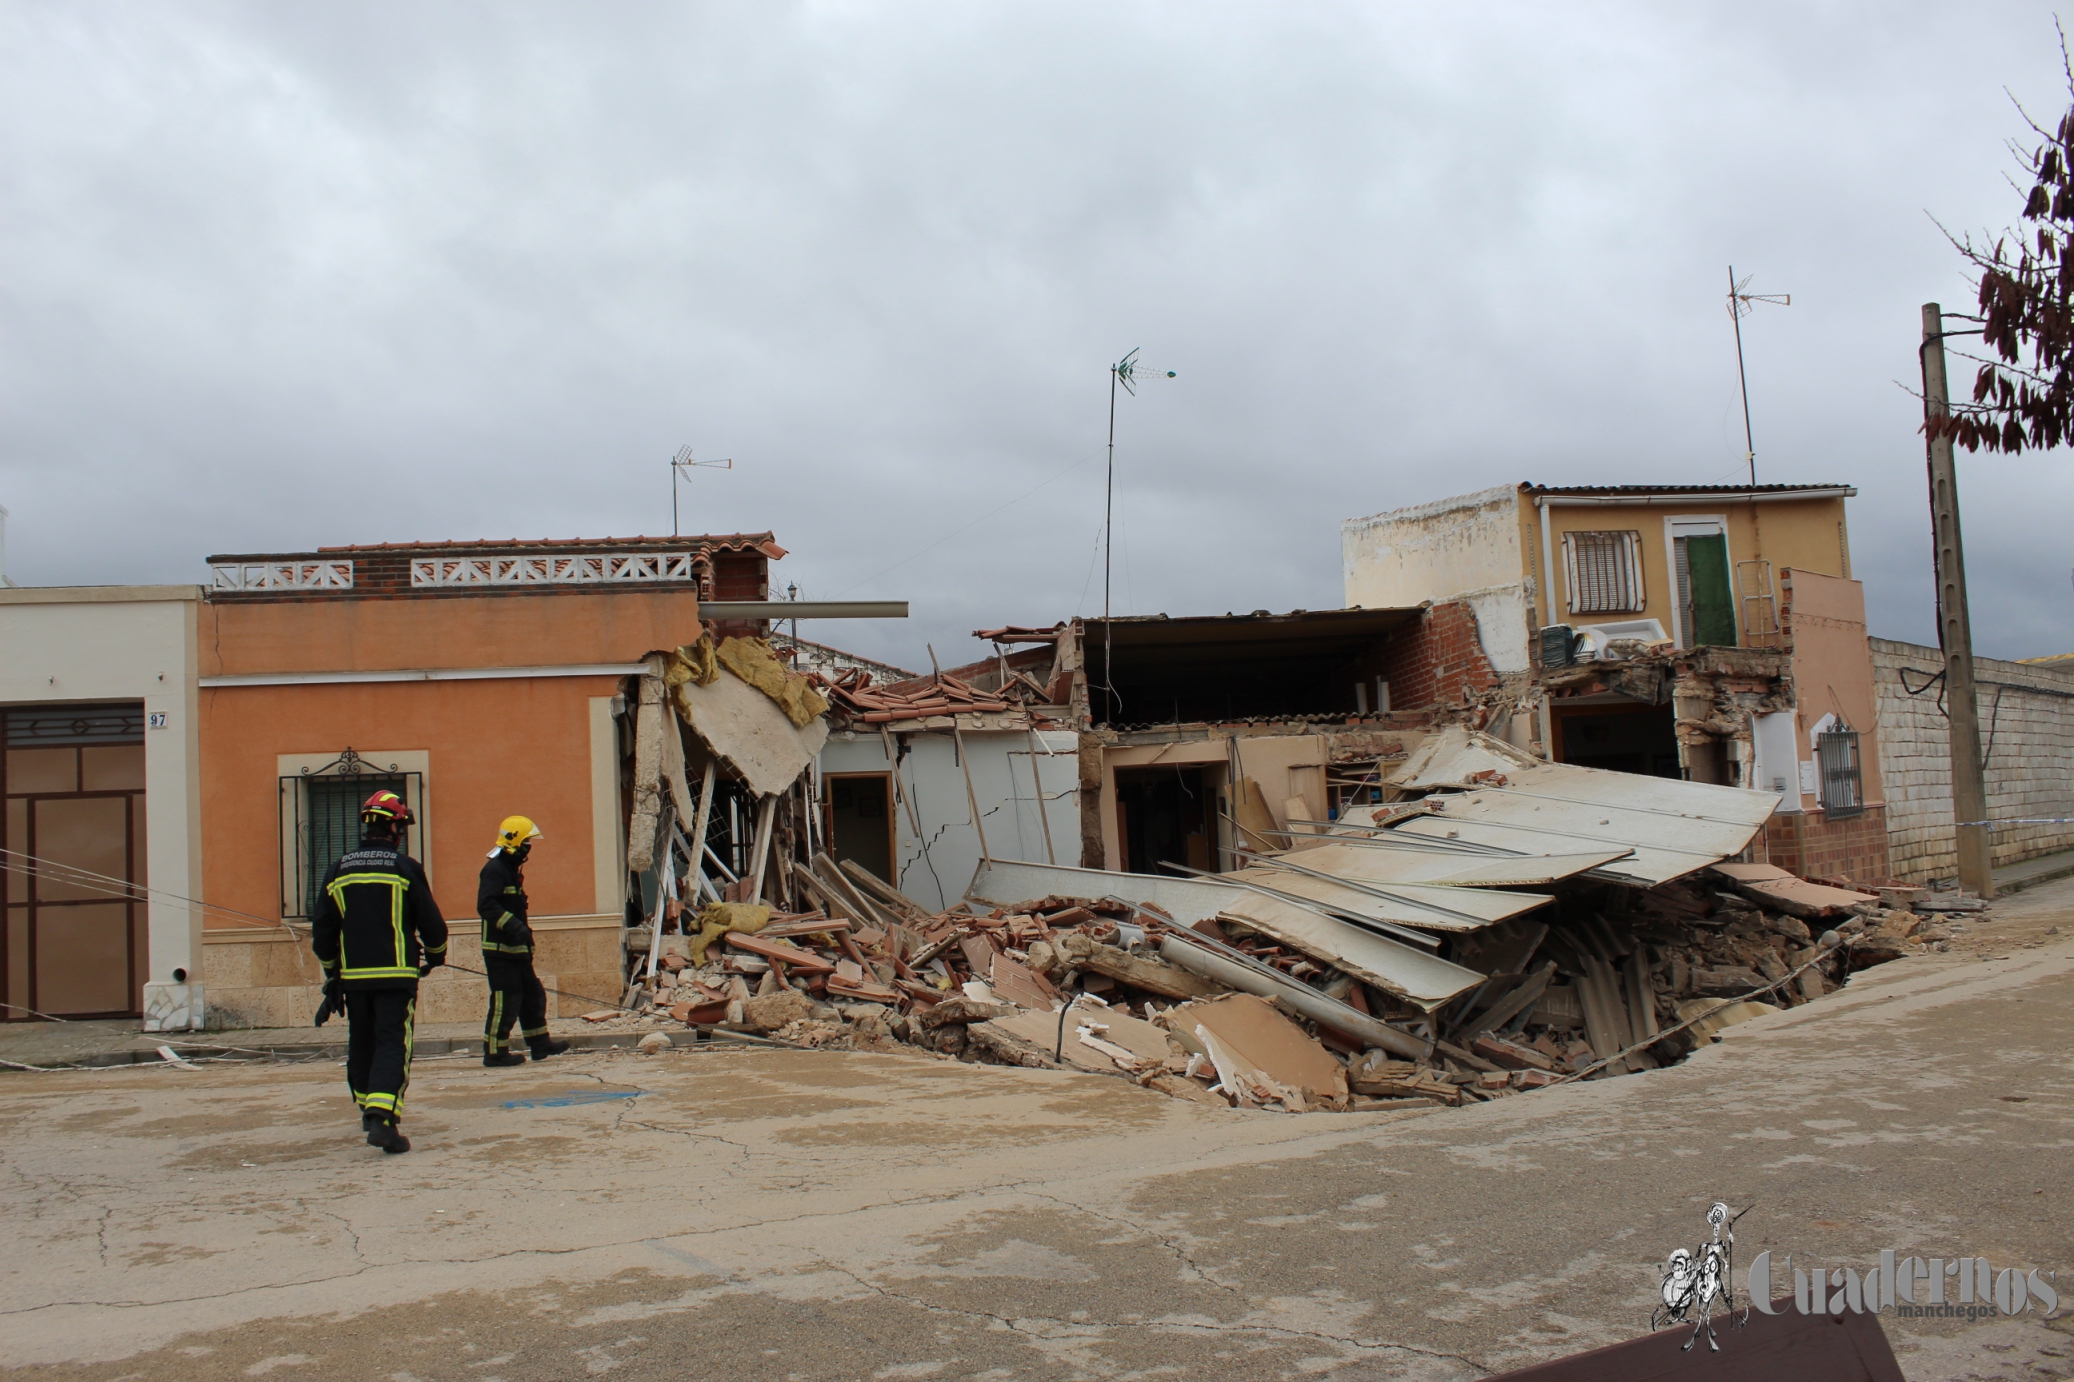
309;793;446;1154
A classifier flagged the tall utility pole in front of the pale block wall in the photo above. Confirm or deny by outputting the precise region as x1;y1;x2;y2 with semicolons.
1921;303;1995;899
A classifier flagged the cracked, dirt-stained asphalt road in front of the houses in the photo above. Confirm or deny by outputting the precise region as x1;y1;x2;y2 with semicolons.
0;884;2074;1382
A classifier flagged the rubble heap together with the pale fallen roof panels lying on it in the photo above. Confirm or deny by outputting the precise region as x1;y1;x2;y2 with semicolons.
605;712;1950;1112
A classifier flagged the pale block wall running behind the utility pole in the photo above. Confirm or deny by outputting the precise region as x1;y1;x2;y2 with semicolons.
1871;639;2074;882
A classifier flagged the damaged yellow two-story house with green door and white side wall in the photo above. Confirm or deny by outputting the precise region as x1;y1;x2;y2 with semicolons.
1342;483;1887;882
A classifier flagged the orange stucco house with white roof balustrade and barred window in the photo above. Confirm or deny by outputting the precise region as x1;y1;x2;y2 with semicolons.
197;533;784;1027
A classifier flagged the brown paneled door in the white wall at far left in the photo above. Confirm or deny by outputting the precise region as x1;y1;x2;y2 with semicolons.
0;701;147;1021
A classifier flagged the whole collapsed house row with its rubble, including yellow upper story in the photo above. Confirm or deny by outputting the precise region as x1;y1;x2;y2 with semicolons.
597;486;1947;1108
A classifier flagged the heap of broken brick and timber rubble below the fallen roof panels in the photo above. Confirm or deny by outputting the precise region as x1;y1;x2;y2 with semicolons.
589;830;1950;1112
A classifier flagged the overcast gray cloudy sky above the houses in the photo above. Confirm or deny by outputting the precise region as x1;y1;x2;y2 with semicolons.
0;0;2074;666
